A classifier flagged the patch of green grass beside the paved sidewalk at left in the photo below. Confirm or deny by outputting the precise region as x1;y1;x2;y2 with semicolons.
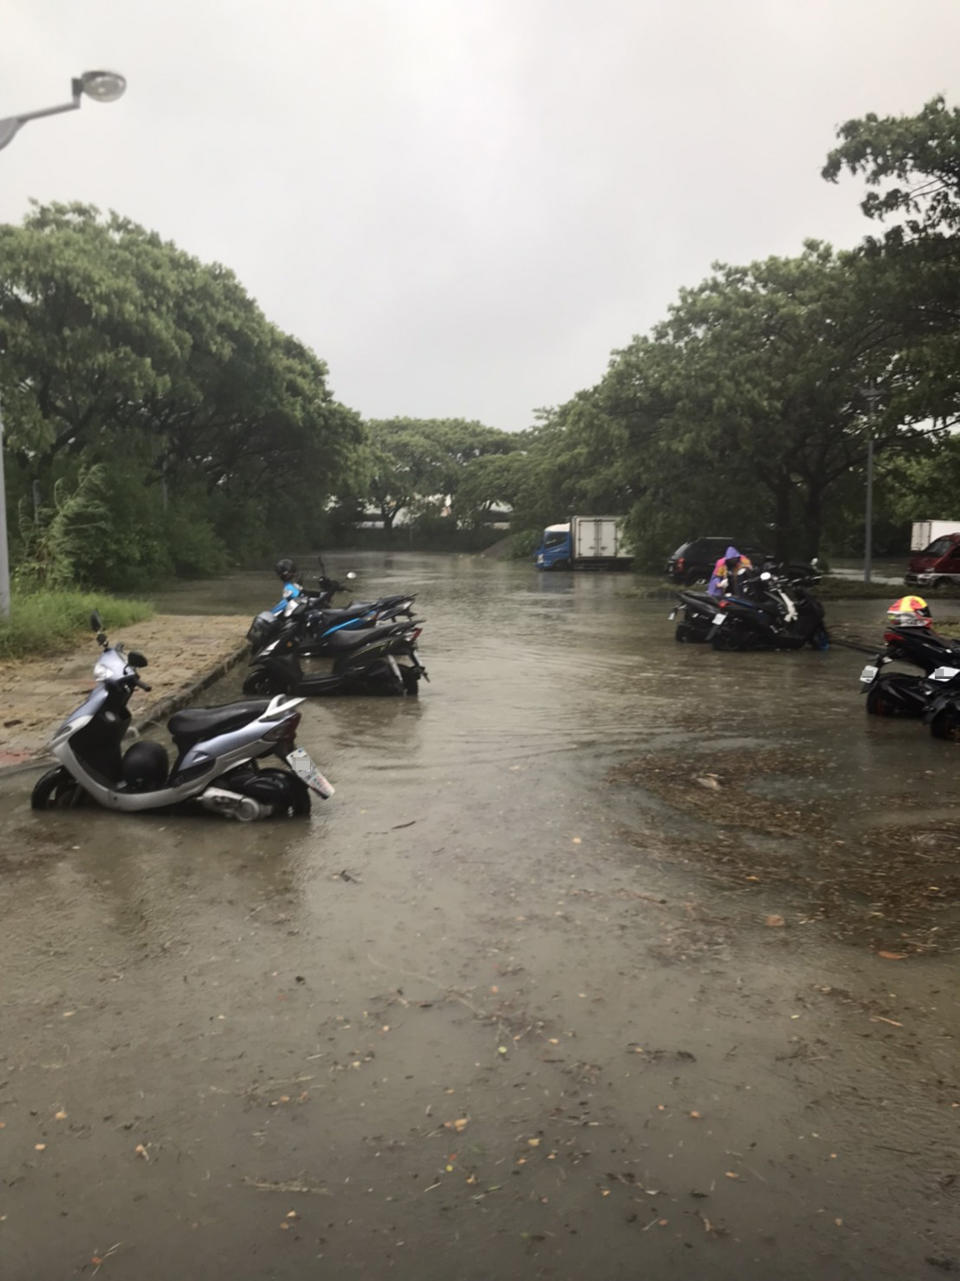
0;592;154;658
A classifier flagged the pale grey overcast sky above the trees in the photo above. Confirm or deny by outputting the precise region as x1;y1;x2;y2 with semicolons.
0;0;960;429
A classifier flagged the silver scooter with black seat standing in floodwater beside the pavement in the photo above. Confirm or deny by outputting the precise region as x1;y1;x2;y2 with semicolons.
31;614;333;821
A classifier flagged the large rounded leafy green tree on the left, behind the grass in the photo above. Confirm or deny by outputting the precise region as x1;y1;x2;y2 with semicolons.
0;204;363;584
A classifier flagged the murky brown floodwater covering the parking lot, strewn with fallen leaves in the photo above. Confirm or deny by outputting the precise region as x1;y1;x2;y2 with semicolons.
0;555;960;1281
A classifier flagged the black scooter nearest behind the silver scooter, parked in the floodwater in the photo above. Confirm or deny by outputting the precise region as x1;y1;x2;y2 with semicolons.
244;602;429;697
